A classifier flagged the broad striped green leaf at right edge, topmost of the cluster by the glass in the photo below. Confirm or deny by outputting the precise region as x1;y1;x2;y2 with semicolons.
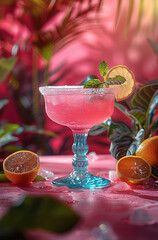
131;80;158;112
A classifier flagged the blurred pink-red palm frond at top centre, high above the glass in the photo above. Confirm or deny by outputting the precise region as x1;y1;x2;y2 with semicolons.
54;0;103;52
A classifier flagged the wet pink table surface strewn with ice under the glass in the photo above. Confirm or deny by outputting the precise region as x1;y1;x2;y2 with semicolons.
0;155;158;240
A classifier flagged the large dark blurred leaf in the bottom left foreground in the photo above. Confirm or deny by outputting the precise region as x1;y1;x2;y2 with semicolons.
0;196;79;233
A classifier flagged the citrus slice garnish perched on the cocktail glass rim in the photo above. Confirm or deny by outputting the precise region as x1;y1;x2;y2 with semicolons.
106;65;135;101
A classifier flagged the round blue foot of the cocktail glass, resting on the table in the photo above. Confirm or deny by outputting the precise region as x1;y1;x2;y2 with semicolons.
52;171;110;188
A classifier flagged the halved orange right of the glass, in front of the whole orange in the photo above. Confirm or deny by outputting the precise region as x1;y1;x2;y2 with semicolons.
116;155;151;184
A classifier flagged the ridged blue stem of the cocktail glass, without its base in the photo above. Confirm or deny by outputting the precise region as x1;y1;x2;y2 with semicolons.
72;133;88;173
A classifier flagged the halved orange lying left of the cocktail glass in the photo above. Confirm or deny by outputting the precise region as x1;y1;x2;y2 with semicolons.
3;150;40;184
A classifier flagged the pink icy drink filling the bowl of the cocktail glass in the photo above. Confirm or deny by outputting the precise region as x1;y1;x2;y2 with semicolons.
44;89;114;132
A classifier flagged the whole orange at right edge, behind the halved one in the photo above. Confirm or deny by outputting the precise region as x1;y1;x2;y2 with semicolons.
135;136;158;178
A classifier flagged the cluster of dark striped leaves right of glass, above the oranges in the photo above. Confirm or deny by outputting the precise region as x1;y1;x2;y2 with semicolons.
89;80;158;160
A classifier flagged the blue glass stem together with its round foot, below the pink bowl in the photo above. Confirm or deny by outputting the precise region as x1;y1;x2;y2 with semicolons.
52;133;110;188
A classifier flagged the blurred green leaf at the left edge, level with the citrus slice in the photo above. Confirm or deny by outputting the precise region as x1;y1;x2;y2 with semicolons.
0;57;17;82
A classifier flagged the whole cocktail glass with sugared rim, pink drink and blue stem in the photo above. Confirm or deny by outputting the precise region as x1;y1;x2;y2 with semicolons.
39;86;119;188
